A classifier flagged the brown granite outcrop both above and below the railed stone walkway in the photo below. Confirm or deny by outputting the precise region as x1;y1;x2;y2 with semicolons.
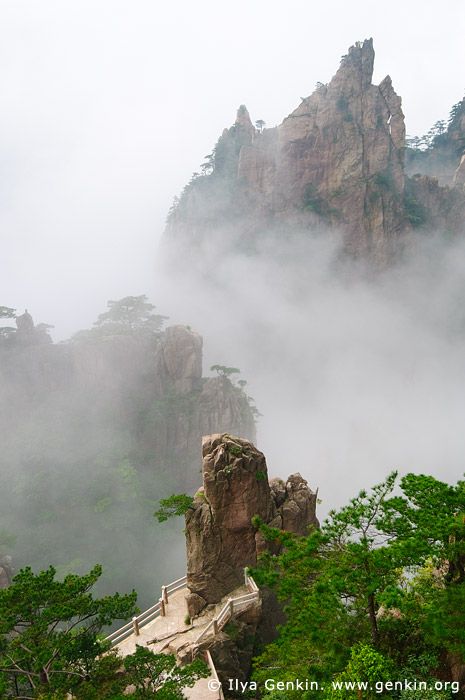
176;433;319;697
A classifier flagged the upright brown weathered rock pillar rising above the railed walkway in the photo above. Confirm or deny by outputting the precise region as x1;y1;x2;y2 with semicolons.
186;434;318;615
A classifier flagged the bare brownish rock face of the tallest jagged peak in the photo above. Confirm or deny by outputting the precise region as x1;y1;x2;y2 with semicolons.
238;40;405;263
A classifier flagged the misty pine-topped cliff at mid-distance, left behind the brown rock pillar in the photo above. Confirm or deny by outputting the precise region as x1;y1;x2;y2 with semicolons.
0;326;255;593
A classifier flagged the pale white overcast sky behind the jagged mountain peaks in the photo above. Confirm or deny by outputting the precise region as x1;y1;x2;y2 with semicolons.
0;0;465;340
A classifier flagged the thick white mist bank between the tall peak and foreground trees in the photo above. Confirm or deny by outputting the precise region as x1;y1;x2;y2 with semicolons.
157;232;465;511
